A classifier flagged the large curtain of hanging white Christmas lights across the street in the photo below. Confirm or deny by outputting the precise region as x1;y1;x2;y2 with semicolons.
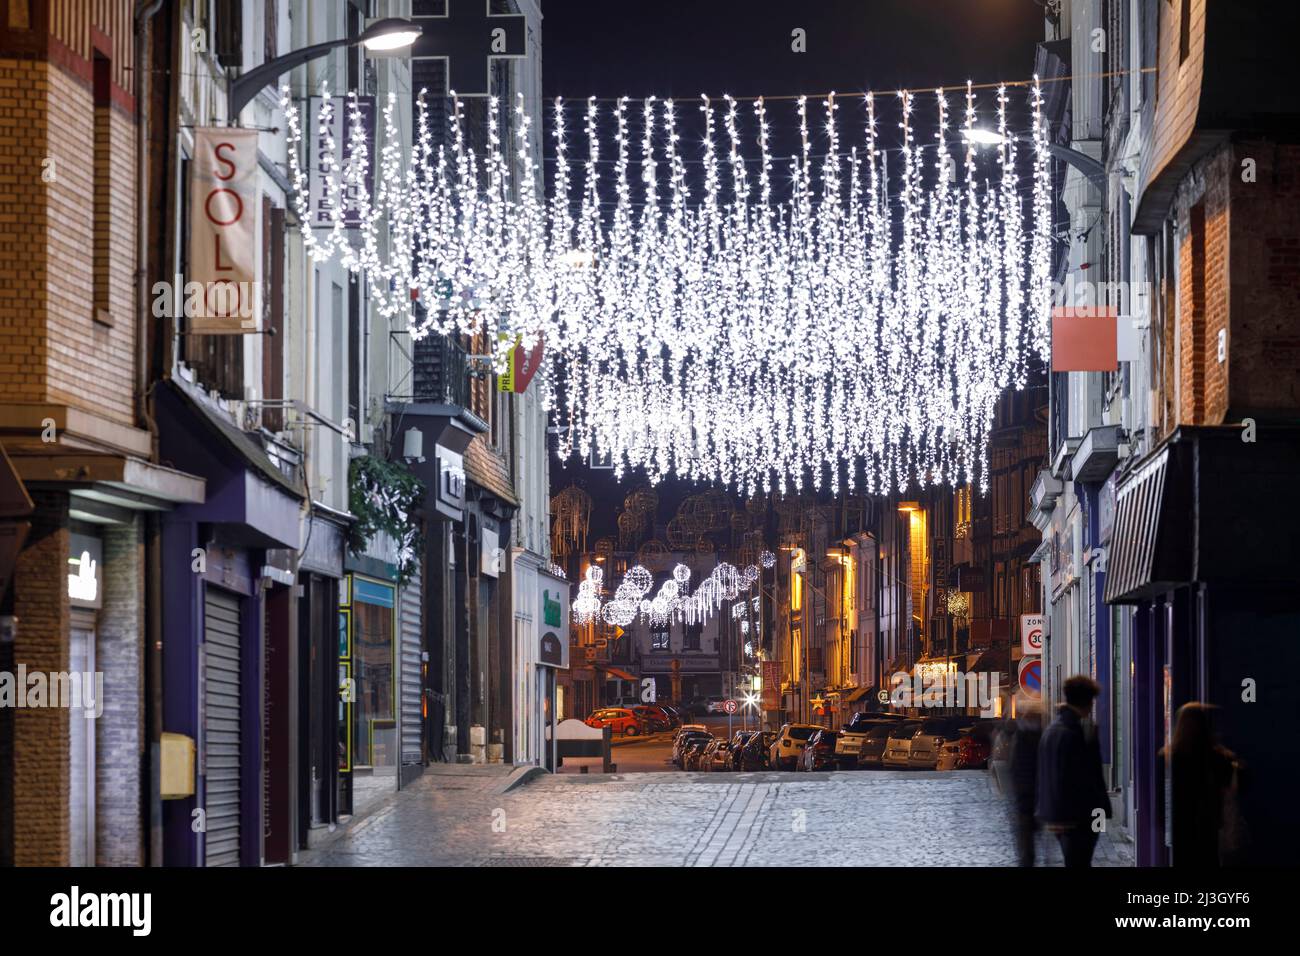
283;79;1050;496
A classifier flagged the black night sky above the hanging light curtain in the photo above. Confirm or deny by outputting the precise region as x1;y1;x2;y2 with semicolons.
542;0;1044;540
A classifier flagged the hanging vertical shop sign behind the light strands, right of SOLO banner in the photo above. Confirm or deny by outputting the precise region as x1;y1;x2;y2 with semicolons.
308;96;374;229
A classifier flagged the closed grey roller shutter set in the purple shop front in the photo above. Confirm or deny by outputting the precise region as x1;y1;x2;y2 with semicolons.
203;585;239;866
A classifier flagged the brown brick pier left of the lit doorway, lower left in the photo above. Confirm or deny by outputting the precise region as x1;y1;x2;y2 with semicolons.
13;492;70;866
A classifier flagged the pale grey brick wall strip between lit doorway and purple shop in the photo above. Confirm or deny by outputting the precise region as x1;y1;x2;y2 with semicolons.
95;518;146;866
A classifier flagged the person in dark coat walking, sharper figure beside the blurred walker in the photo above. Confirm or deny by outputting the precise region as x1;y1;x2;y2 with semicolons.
1036;675;1110;866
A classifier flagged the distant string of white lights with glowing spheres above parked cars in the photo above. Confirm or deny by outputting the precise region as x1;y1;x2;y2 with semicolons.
571;561;761;627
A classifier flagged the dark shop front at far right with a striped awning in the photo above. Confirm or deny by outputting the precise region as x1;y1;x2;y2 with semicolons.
1105;427;1300;866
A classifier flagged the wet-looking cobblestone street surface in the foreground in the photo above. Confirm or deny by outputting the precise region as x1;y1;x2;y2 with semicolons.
300;766;1132;866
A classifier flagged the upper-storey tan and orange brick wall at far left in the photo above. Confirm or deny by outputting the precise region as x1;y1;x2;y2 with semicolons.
0;60;137;424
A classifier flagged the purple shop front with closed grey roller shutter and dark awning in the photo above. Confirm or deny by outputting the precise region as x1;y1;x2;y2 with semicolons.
157;382;304;866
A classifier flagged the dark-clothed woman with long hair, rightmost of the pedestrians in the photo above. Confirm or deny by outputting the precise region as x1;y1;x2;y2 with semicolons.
1161;701;1238;866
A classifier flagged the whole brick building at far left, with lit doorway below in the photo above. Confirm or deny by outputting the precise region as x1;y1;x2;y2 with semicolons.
0;0;203;865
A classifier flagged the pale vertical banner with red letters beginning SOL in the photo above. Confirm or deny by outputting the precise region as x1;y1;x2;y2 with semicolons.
185;126;261;336
